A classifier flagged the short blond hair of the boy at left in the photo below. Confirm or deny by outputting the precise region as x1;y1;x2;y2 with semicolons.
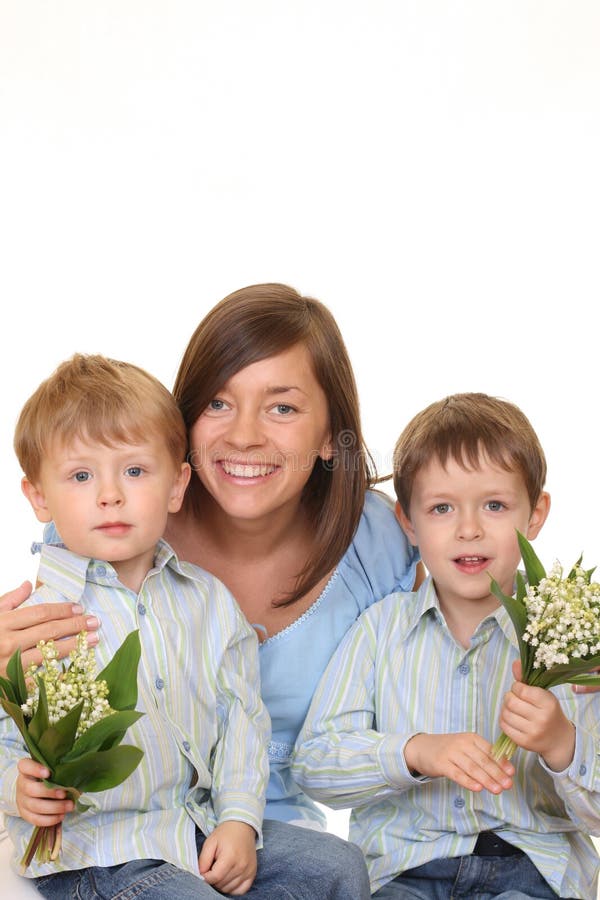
14;353;187;482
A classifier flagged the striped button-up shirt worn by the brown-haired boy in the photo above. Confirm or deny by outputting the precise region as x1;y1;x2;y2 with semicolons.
292;579;600;898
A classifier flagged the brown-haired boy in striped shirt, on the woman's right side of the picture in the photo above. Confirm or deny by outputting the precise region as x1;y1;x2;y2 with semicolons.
293;394;600;900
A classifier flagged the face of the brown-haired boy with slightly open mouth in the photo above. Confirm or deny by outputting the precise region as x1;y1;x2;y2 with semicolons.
399;457;550;610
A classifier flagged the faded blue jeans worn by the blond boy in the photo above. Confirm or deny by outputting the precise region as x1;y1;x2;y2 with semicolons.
34;819;371;900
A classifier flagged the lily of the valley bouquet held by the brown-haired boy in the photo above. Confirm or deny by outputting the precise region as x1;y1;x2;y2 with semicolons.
491;532;600;759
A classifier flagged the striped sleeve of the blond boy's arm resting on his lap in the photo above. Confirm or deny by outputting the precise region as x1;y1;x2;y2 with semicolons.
212;601;271;846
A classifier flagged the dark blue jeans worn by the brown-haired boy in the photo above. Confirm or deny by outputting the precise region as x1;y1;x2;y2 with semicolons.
373;854;558;900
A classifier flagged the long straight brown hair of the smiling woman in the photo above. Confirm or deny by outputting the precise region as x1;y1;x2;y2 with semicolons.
173;284;374;605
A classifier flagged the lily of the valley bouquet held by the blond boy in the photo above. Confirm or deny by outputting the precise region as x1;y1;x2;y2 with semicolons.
0;631;144;872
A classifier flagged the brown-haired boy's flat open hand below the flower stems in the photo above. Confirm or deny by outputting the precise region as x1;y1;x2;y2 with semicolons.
404;732;515;794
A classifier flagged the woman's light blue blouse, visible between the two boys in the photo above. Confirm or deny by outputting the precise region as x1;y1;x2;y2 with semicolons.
259;491;419;827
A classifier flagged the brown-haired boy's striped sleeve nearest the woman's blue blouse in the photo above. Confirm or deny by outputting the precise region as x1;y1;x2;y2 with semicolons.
292;607;422;809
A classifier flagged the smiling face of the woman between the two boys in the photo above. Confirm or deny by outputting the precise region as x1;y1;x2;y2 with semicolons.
190;344;332;520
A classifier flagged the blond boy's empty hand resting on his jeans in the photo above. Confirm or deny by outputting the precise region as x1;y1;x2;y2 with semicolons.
198;822;256;896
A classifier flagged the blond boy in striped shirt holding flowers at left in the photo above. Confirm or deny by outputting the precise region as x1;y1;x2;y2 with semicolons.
0;355;275;900
